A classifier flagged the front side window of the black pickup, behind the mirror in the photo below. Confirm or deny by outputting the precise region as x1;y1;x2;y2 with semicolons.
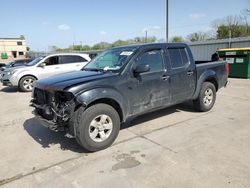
137;50;163;72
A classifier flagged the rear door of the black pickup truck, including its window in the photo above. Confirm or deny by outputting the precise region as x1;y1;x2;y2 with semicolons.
167;47;196;104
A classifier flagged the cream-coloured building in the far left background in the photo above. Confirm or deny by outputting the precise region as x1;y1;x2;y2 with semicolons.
0;35;27;59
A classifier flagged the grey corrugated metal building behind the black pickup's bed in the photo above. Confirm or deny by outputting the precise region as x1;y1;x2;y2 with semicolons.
188;37;250;61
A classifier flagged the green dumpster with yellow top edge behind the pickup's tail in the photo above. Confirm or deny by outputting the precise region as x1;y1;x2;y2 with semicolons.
218;47;250;78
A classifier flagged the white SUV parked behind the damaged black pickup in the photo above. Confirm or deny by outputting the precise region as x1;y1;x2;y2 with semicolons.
1;53;91;92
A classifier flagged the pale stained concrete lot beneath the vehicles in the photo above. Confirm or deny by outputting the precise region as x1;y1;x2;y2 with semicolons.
0;79;250;188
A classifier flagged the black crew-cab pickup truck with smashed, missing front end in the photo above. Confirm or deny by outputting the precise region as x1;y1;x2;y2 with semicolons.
31;43;229;151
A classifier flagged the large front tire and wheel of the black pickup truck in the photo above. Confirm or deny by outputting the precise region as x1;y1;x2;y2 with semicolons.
75;103;120;152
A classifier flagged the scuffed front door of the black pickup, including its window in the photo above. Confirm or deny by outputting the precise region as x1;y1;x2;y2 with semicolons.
130;48;170;114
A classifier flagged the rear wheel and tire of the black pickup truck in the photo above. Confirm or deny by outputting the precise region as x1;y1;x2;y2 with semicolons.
193;82;216;112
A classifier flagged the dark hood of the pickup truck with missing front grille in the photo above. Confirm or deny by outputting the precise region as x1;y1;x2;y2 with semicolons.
35;71;115;92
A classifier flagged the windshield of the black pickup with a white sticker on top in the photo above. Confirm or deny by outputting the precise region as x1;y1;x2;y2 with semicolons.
83;47;137;71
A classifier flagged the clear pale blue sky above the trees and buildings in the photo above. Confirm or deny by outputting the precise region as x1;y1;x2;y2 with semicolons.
0;0;250;51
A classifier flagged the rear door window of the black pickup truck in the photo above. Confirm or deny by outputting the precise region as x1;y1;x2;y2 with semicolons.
168;48;189;68
